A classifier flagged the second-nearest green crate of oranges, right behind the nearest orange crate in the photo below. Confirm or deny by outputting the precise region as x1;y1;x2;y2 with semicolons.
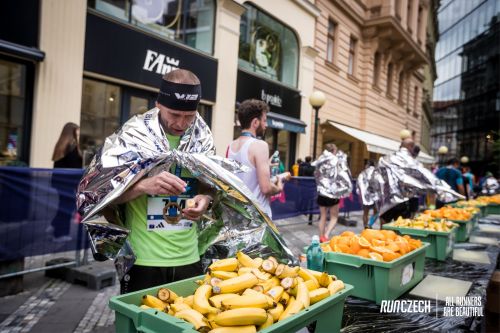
382;223;457;261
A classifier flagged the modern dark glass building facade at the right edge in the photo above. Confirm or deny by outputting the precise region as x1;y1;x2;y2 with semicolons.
432;0;500;176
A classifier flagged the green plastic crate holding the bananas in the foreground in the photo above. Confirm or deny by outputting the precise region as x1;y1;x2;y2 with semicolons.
109;275;353;333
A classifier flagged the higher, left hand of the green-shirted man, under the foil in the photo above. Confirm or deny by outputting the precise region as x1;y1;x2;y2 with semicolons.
137;171;187;195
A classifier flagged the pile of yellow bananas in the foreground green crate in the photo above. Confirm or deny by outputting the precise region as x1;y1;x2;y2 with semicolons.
141;252;344;333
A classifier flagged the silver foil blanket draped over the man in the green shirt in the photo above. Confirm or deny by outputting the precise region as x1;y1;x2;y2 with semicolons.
77;108;296;278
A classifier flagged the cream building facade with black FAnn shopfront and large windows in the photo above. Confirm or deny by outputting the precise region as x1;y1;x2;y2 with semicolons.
0;0;319;167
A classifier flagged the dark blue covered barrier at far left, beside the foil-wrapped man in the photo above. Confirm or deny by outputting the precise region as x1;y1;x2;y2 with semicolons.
0;167;87;279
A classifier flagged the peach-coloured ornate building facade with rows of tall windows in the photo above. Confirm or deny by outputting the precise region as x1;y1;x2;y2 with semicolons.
311;0;435;175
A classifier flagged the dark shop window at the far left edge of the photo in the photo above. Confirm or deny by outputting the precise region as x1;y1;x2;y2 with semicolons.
0;59;29;165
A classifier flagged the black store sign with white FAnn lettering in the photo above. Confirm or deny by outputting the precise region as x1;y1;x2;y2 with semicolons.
84;13;218;102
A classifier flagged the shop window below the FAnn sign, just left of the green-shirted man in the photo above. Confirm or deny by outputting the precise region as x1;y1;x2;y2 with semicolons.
80;79;121;165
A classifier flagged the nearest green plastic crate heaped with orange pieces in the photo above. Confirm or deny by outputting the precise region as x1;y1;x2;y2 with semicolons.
325;243;429;304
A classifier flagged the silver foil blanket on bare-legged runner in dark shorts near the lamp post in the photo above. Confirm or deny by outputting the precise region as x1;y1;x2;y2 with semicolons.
312;150;352;199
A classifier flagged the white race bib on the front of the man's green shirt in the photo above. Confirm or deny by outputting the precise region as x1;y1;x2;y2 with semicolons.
146;178;198;231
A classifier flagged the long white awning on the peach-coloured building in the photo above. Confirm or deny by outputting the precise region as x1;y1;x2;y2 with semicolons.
328;120;435;163
